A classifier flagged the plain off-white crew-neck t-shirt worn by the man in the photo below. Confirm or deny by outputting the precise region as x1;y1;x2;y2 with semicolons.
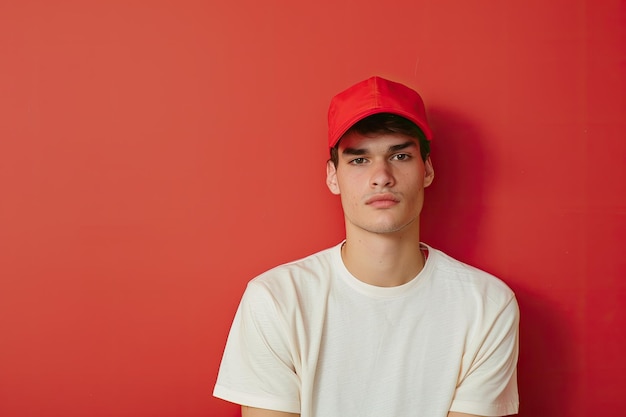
213;245;519;417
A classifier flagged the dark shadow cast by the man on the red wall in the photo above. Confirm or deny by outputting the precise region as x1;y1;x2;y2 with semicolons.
421;107;572;417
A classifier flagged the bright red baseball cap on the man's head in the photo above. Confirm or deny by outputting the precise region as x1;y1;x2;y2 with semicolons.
328;77;432;148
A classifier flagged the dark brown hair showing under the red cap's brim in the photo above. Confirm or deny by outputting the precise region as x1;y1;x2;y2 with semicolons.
330;113;430;166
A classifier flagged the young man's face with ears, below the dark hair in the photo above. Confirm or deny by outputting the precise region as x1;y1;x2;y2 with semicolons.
326;132;434;234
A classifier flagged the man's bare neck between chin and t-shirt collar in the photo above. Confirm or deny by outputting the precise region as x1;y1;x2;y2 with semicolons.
341;231;424;287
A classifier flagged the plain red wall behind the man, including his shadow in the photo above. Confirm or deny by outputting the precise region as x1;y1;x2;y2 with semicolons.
0;0;626;417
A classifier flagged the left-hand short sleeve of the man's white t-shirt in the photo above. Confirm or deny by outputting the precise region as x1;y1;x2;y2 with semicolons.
213;281;300;413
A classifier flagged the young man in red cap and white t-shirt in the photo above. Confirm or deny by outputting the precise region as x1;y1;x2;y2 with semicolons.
214;77;519;417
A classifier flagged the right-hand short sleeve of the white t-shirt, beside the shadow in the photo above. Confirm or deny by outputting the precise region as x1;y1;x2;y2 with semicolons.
450;297;519;416
